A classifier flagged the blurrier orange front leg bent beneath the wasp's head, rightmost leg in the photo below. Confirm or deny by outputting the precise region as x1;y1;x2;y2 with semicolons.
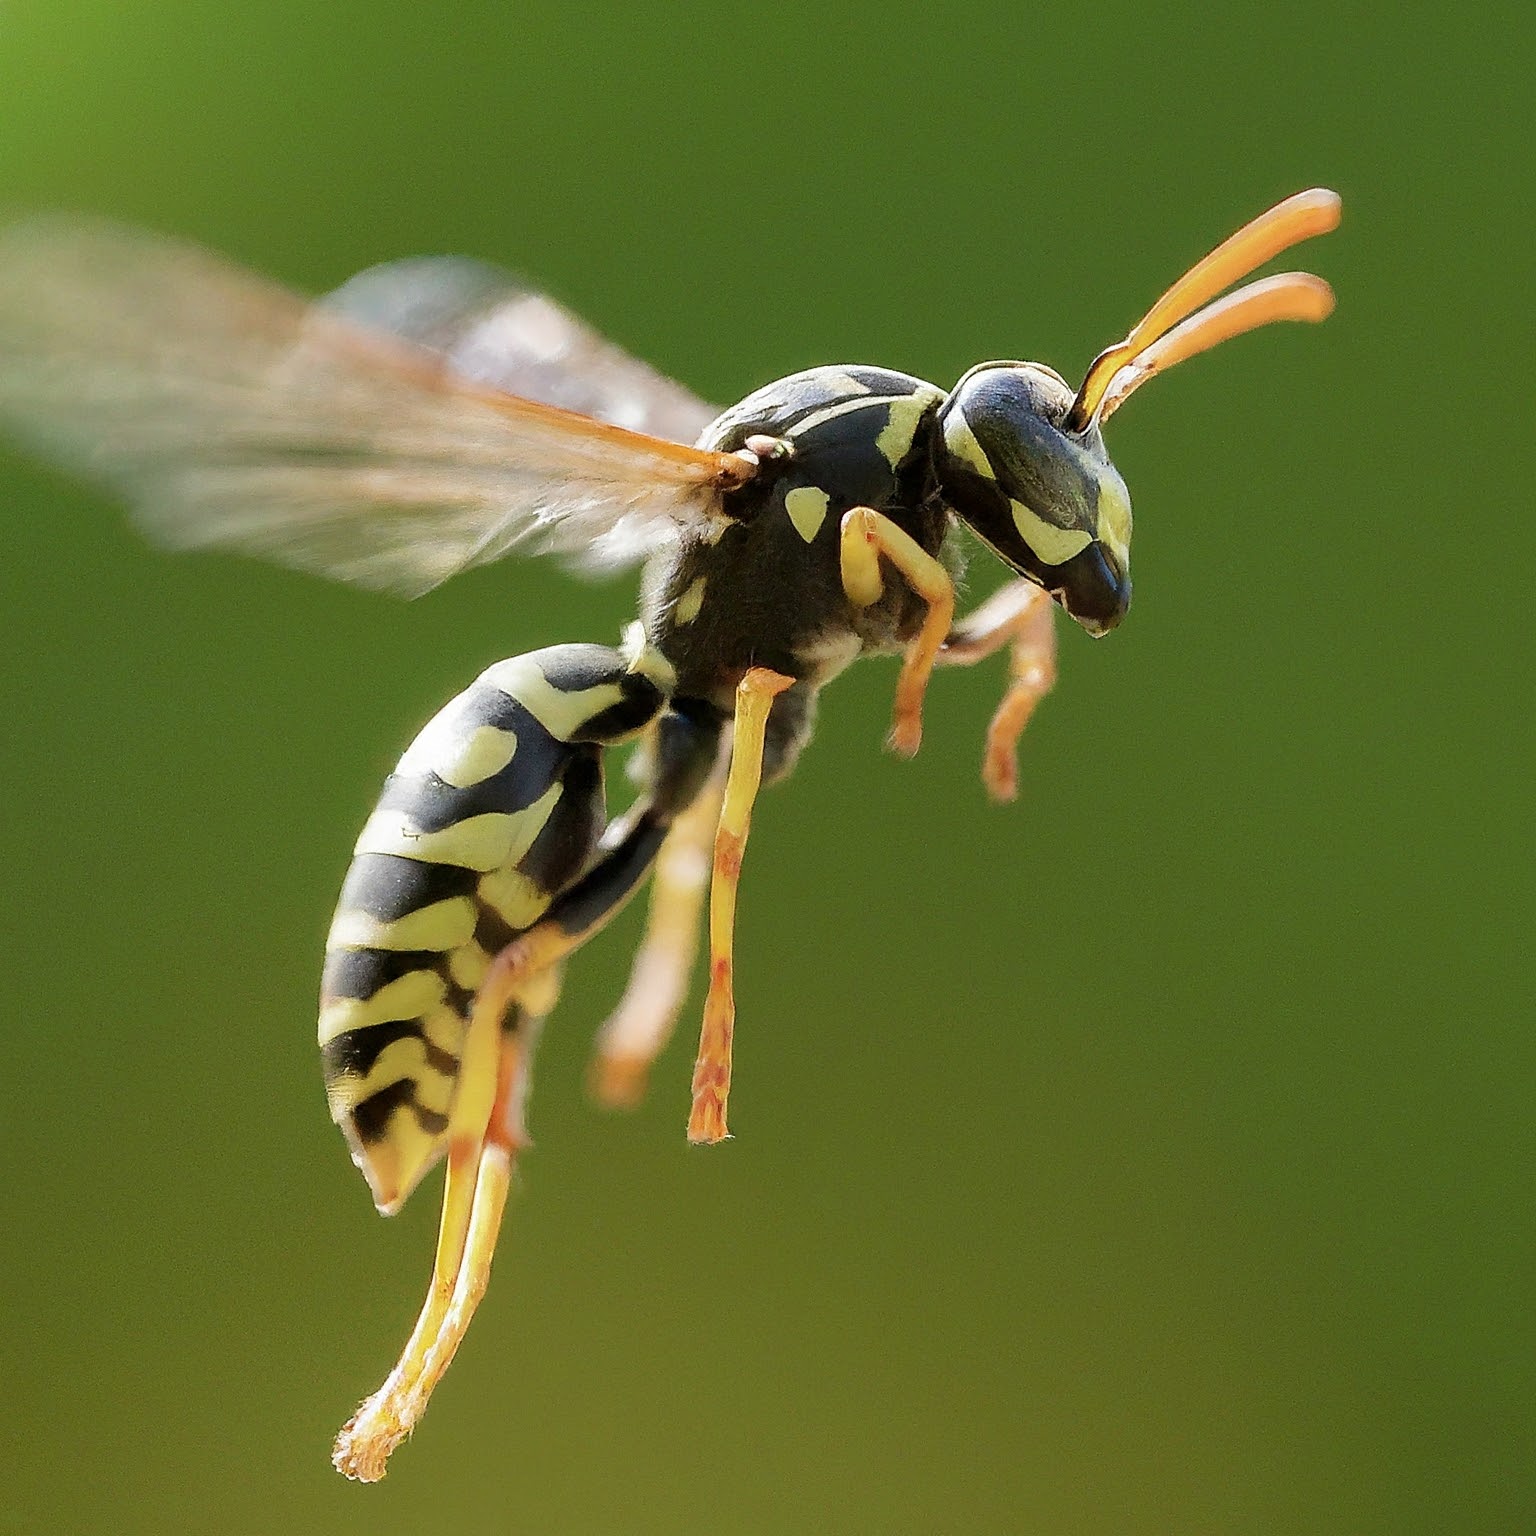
938;581;1055;800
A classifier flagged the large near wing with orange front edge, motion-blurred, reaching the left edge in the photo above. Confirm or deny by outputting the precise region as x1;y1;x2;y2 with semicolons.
0;218;751;594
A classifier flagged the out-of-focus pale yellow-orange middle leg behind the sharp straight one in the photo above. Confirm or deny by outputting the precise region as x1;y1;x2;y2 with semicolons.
587;771;725;1109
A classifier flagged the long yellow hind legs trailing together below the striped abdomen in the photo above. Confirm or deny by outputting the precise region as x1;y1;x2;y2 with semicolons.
330;974;559;1482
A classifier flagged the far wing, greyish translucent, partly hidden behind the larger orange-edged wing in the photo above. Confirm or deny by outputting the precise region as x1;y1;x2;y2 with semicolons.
321;257;720;442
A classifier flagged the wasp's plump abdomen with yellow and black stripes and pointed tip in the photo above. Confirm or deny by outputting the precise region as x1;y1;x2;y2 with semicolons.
319;645;664;1212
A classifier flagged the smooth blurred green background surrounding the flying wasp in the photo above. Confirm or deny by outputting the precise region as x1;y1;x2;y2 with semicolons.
0;0;1536;1536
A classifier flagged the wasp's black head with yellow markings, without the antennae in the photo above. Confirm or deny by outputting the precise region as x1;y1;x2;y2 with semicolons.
937;362;1130;634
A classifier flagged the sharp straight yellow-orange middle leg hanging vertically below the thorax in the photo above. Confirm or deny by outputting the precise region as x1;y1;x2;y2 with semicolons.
688;667;794;1143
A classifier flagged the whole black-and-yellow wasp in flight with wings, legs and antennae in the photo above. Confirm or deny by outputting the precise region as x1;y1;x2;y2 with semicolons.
0;189;1339;1481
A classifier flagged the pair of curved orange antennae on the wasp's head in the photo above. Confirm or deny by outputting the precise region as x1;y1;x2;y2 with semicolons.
1063;187;1342;432
